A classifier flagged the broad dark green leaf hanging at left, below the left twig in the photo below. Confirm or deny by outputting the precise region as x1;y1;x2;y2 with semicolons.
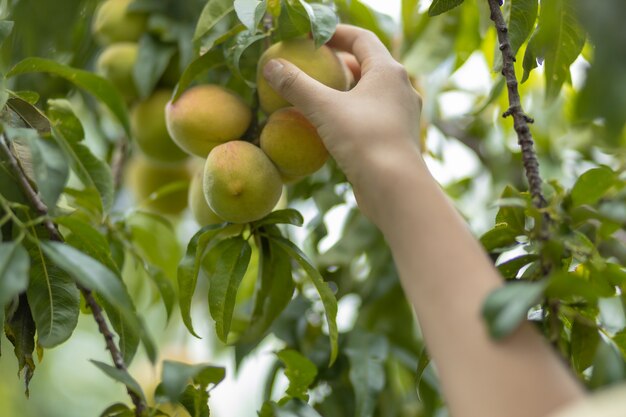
27;237;80;348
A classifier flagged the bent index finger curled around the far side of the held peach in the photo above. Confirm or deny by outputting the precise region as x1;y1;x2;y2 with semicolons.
328;25;394;73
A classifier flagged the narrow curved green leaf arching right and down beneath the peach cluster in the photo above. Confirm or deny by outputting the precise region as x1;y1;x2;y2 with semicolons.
271;236;339;365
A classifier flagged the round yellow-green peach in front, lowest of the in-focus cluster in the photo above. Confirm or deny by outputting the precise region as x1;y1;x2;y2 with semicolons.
203;141;282;223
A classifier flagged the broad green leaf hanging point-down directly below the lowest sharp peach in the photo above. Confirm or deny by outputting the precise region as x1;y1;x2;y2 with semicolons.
202;236;252;343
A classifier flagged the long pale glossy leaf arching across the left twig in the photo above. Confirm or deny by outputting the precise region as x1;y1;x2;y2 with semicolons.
41;242;156;362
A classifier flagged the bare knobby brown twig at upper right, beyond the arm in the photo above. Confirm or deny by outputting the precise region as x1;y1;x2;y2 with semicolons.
487;0;547;211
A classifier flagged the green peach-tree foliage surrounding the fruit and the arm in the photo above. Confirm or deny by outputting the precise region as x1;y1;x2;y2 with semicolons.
0;0;626;417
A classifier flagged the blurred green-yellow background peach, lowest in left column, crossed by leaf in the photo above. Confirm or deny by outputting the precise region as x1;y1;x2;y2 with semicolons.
127;156;191;215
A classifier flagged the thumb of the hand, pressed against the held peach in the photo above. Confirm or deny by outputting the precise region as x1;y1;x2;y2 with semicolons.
263;59;332;113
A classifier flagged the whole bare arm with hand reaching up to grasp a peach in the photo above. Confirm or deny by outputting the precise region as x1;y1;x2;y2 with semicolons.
264;25;584;417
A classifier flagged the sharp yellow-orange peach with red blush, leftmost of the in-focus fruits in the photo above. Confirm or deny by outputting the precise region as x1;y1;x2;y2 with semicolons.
165;85;252;158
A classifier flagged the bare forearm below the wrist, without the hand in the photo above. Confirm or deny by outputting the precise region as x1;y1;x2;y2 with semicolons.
354;148;583;417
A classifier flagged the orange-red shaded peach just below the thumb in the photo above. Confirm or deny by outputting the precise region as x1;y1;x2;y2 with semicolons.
261;107;328;182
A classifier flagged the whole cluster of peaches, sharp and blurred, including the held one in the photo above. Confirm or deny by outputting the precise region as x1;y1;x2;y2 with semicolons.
94;0;348;225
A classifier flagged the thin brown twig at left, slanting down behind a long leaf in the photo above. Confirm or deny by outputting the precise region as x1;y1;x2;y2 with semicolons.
0;135;147;417
